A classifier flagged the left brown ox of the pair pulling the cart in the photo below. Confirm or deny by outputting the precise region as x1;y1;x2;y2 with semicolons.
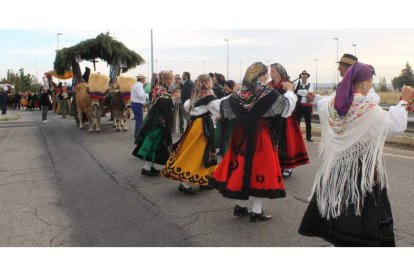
75;82;103;132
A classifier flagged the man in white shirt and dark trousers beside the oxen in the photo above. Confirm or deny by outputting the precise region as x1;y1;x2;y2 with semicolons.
131;74;147;139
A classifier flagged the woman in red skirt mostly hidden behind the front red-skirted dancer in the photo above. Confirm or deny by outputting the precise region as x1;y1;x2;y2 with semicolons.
268;63;309;178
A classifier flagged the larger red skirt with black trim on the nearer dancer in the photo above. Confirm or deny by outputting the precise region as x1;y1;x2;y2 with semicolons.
209;119;286;199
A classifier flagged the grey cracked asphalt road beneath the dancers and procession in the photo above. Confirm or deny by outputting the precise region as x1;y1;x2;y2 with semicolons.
0;111;414;247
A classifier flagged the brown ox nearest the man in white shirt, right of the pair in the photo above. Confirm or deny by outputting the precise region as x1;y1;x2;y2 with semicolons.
109;83;131;132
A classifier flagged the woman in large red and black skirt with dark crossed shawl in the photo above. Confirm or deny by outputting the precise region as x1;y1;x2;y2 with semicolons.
209;62;297;222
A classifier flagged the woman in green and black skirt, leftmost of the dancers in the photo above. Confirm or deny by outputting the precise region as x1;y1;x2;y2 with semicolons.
132;71;174;176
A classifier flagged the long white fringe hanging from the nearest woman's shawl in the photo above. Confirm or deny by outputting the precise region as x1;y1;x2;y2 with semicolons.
309;108;388;220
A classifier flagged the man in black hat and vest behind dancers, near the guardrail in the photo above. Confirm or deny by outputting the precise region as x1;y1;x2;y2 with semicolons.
293;70;314;142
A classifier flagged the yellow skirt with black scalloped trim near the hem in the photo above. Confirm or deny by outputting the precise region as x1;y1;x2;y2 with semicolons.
161;118;217;185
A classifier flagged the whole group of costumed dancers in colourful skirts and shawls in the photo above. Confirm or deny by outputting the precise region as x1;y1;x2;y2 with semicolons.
131;55;414;246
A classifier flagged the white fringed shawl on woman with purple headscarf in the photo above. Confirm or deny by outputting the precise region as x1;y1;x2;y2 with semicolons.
312;94;389;220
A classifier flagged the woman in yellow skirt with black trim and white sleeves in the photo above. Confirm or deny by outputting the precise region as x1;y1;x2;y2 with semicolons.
161;74;220;195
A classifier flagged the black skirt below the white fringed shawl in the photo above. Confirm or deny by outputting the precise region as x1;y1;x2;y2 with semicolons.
298;185;395;247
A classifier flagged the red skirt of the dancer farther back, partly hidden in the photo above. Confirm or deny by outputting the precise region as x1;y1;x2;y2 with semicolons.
279;116;309;169
